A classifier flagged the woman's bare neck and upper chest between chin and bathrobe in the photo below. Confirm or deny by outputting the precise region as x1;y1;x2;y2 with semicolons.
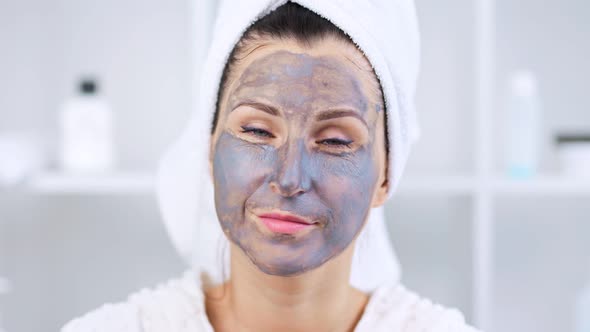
207;244;368;331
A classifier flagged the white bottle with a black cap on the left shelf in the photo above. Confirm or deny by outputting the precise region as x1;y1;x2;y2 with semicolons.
58;79;115;173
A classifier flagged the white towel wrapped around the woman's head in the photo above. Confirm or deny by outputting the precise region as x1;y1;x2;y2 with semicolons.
157;0;420;291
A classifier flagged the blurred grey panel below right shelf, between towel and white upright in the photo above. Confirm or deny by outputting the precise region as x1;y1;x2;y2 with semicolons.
386;195;473;321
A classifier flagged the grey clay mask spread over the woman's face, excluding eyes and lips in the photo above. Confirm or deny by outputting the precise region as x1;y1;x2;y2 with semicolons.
213;51;380;276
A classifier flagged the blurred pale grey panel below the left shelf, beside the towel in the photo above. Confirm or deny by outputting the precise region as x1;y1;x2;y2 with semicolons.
0;194;184;332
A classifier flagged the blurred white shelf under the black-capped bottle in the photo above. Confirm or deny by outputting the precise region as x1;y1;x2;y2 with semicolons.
25;172;155;194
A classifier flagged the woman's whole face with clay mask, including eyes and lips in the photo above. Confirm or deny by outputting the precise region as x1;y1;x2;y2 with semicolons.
211;39;387;276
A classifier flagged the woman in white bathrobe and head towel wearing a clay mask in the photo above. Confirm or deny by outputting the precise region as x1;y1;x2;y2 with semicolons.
63;0;484;332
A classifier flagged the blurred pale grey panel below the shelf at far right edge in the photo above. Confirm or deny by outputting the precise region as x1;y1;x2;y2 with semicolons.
493;196;590;332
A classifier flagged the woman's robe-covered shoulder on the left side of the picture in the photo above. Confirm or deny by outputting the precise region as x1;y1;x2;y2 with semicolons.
61;271;207;332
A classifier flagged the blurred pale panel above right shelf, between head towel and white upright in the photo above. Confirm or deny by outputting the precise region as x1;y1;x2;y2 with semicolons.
407;0;475;175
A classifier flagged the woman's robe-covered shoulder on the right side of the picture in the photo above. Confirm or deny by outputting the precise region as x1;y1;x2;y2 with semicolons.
360;283;480;332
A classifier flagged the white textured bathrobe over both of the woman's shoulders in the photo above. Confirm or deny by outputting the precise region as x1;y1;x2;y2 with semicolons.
61;270;484;332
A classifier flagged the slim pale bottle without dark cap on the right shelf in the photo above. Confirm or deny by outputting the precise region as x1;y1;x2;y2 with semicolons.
505;71;541;179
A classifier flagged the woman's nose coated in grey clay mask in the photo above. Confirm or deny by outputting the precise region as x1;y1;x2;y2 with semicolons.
270;140;311;197
